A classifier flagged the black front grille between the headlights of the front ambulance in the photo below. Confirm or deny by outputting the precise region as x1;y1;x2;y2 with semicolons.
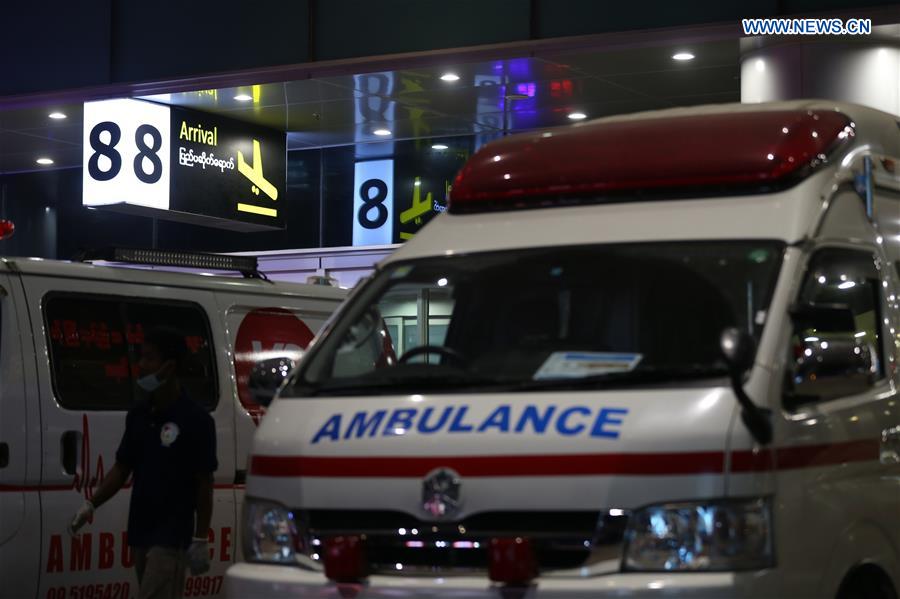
295;510;627;575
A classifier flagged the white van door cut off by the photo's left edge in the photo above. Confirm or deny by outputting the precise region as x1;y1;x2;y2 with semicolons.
0;274;41;599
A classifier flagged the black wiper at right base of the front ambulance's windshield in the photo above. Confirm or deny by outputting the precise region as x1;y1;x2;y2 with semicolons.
509;365;728;391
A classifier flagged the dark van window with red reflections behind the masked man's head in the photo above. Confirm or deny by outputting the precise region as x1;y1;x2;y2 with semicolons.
44;294;218;410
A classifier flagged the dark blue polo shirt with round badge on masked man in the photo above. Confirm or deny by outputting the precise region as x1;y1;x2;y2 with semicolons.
116;395;218;548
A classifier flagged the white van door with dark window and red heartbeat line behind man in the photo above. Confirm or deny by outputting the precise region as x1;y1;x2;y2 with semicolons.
26;277;234;599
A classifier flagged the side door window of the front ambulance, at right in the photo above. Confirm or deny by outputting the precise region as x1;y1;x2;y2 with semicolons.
789;248;884;400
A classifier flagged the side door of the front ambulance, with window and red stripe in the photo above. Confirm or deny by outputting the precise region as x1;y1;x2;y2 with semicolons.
776;243;900;595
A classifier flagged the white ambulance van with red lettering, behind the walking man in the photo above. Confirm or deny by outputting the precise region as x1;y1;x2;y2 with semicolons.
0;250;346;599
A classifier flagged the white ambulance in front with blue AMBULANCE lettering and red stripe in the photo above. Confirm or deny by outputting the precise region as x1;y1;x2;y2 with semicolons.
226;101;900;599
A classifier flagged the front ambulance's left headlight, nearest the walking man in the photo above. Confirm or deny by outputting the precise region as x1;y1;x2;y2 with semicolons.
243;498;303;564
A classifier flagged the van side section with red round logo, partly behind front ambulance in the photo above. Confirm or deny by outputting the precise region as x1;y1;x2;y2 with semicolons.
217;293;340;560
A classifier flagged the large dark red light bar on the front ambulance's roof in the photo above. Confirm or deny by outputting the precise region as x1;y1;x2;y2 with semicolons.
449;110;854;212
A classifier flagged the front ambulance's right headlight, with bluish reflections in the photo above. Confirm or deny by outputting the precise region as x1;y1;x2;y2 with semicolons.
623;499;773;571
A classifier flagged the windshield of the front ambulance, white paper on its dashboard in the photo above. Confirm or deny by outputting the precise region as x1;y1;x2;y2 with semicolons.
292;241;784;396
